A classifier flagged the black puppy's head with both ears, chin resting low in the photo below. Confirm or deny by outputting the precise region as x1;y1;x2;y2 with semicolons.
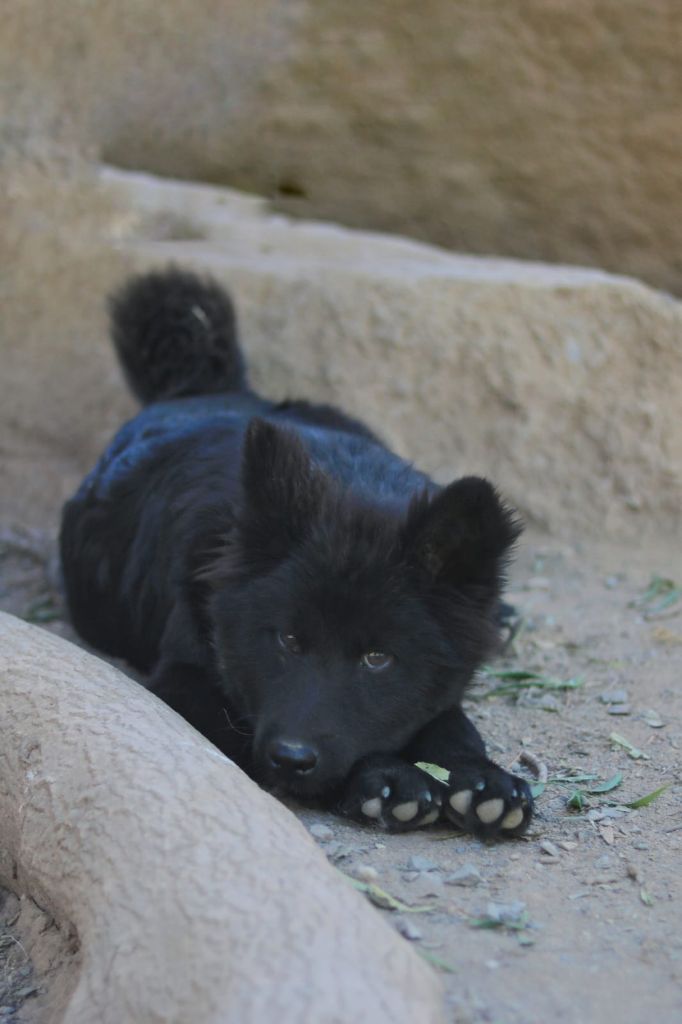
204;421;520;797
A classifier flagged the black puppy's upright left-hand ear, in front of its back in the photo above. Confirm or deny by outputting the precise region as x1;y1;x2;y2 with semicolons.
238;419;326;567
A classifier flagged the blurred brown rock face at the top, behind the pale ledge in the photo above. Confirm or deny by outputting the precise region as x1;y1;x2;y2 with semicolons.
0;0;682;292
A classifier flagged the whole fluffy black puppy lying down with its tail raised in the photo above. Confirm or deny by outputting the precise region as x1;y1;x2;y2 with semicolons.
60;270;532;837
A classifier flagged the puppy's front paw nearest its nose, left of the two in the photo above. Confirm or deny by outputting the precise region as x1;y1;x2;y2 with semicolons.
339;756;446;831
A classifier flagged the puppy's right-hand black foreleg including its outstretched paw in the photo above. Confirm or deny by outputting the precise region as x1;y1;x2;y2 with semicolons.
403;708;532;839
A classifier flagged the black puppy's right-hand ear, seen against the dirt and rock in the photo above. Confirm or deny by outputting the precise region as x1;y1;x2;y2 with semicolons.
404;476;523;603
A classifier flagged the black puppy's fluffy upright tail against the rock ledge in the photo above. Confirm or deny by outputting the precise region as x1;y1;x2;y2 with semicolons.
109;267;247;404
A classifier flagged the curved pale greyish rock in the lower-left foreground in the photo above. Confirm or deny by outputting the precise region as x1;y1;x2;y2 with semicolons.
0;614;442;1024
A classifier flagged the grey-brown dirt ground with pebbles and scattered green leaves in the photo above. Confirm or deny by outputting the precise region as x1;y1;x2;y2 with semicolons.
0;526;682;1024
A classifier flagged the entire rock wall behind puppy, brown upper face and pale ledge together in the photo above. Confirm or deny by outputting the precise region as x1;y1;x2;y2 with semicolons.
0;0;682;541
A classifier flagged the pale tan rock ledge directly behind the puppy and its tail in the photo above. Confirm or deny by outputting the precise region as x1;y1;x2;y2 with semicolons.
0;159;682;540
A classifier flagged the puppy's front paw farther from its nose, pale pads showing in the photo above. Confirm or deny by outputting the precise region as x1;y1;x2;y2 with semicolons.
443;761;532;839
